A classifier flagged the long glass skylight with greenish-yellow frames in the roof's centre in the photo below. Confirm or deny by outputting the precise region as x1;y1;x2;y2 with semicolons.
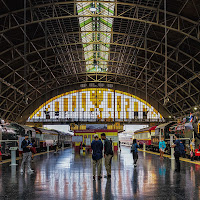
77;0;115;72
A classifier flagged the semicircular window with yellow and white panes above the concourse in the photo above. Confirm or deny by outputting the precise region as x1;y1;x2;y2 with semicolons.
28;88;164;122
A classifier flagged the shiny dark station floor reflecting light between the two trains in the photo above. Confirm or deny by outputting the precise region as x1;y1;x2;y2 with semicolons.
0;146;200;200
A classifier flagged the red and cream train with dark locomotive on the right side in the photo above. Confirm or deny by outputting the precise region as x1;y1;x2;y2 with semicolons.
119;113;200;159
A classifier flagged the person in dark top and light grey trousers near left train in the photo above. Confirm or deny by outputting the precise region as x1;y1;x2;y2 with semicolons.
20;134;33;173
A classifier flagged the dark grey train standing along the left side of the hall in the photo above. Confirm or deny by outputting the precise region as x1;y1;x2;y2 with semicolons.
0;123;73;159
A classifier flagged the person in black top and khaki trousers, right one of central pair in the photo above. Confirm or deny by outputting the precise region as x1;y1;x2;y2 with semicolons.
101;133;113;178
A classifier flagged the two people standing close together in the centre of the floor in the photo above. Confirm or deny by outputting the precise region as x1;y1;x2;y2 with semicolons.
91;133;113;180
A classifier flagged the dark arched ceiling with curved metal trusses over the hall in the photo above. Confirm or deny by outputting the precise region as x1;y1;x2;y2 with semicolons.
0;0;200;120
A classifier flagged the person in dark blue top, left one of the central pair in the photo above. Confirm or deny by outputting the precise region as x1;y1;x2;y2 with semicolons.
91;134;103;180
